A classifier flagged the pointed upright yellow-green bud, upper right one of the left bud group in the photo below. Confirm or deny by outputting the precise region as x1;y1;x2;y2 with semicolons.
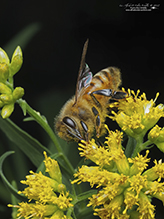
10;46;23;77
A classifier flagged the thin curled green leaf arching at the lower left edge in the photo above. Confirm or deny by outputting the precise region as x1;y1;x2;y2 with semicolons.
0;151;27;201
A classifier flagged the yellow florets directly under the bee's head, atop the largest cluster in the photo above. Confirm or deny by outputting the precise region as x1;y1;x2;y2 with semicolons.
78;125;129;174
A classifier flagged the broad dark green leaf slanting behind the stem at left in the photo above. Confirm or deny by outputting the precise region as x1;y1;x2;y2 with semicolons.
0;117;51;167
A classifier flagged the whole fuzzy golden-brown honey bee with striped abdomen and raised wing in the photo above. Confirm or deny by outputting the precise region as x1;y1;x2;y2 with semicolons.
55;40;127;142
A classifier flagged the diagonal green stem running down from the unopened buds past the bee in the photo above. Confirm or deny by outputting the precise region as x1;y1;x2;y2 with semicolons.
17;99;75;174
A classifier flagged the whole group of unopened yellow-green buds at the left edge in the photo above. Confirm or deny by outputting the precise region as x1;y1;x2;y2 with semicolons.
0;46;24;119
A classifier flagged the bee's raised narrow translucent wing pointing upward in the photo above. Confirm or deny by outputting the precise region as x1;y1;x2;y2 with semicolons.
74;39;92;104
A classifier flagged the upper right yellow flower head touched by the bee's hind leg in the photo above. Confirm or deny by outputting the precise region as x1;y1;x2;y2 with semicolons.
110;90;164;138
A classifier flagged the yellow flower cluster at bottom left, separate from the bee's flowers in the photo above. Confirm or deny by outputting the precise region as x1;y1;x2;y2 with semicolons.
8;152;73;219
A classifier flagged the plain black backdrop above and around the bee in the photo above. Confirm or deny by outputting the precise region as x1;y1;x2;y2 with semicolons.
0;0;164;218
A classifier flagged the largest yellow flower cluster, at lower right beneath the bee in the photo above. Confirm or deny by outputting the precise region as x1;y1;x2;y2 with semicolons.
72;128;164;219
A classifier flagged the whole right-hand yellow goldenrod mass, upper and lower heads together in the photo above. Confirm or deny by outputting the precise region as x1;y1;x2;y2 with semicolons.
72;90;164;219
